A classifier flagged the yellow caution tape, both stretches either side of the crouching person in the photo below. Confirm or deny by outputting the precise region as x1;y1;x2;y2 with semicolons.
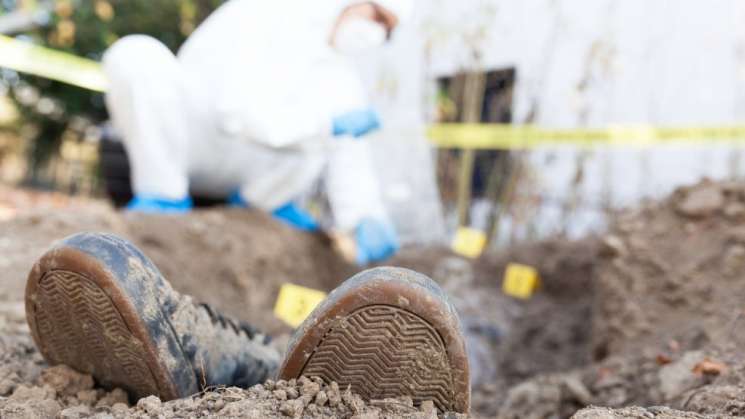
0;35;745;150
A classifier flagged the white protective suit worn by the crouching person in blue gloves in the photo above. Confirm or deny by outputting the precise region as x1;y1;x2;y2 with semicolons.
104;0;398;230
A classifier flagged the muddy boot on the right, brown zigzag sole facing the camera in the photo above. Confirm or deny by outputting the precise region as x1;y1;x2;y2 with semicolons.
279;268;470;413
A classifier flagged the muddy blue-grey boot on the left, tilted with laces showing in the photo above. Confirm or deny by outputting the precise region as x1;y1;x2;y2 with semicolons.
26;234;279;400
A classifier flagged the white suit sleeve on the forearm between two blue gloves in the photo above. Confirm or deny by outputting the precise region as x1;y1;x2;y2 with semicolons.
325;138;388;231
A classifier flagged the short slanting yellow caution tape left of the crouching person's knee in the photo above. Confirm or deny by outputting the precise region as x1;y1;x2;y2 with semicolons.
0;35;108;92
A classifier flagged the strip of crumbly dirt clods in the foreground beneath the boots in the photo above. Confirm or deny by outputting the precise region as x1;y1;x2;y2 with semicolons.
0;366;454;419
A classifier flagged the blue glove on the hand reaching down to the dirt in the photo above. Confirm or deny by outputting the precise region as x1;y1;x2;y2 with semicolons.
355;218;400;266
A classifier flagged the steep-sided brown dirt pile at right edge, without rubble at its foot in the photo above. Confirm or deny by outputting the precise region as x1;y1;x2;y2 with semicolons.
593;181;745;358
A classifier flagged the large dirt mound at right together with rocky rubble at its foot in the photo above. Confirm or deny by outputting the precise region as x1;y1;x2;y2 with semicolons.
498;182;745;419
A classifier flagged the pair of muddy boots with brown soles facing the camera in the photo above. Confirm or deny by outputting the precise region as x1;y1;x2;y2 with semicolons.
26;233;470;413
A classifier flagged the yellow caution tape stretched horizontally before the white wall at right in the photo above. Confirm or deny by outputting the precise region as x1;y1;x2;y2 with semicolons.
428;124;745;150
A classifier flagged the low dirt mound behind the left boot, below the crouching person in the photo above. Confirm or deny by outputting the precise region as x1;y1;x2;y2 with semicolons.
0;203;354;334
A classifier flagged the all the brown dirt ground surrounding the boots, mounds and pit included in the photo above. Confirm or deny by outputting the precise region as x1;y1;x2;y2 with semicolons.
0;182;745;419
